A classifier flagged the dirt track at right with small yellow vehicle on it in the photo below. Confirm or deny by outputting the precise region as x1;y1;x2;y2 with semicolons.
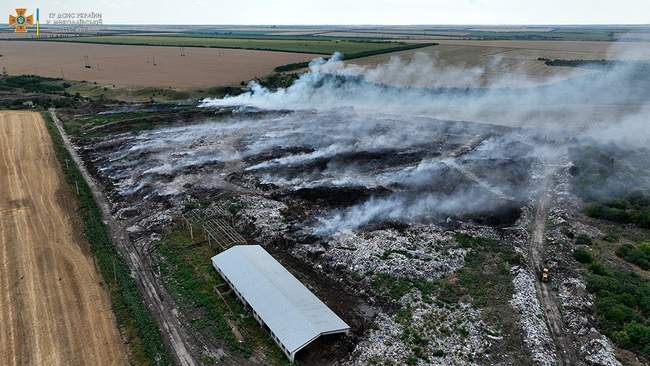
530;166;578;365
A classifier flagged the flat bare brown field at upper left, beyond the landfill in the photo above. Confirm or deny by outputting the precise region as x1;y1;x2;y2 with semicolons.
0;41;318;88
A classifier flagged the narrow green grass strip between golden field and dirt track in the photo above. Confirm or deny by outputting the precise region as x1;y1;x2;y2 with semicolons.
44;114;172;365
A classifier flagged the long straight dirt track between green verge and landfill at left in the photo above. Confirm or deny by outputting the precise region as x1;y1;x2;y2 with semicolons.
50;110;198;366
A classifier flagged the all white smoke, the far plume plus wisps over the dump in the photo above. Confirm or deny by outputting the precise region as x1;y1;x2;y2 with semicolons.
197;44;650;235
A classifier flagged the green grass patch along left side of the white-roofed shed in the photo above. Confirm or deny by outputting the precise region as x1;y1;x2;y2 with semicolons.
158;226;288;365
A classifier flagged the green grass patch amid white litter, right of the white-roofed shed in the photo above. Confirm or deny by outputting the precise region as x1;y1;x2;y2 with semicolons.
371;234;525;365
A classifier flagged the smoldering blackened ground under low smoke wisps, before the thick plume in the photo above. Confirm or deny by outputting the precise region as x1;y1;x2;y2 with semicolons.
95;106;537;235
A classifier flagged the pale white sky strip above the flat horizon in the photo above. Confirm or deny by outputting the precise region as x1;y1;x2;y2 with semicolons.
0;0;650;25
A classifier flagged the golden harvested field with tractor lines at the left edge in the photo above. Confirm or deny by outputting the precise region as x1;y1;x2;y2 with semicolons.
0;111;127;366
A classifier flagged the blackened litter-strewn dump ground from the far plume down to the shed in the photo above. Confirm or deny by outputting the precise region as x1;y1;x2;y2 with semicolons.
58;103;624;365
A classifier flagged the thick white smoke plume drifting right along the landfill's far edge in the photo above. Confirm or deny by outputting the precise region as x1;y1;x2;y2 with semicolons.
204;44;649;137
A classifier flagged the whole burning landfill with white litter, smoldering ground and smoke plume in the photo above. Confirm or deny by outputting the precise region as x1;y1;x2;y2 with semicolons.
77;44;650;365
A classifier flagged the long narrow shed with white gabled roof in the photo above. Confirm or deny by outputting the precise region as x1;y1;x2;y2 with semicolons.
212;245;350;362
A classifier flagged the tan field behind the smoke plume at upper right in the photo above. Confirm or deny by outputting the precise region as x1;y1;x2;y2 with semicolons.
350;40;650;86
